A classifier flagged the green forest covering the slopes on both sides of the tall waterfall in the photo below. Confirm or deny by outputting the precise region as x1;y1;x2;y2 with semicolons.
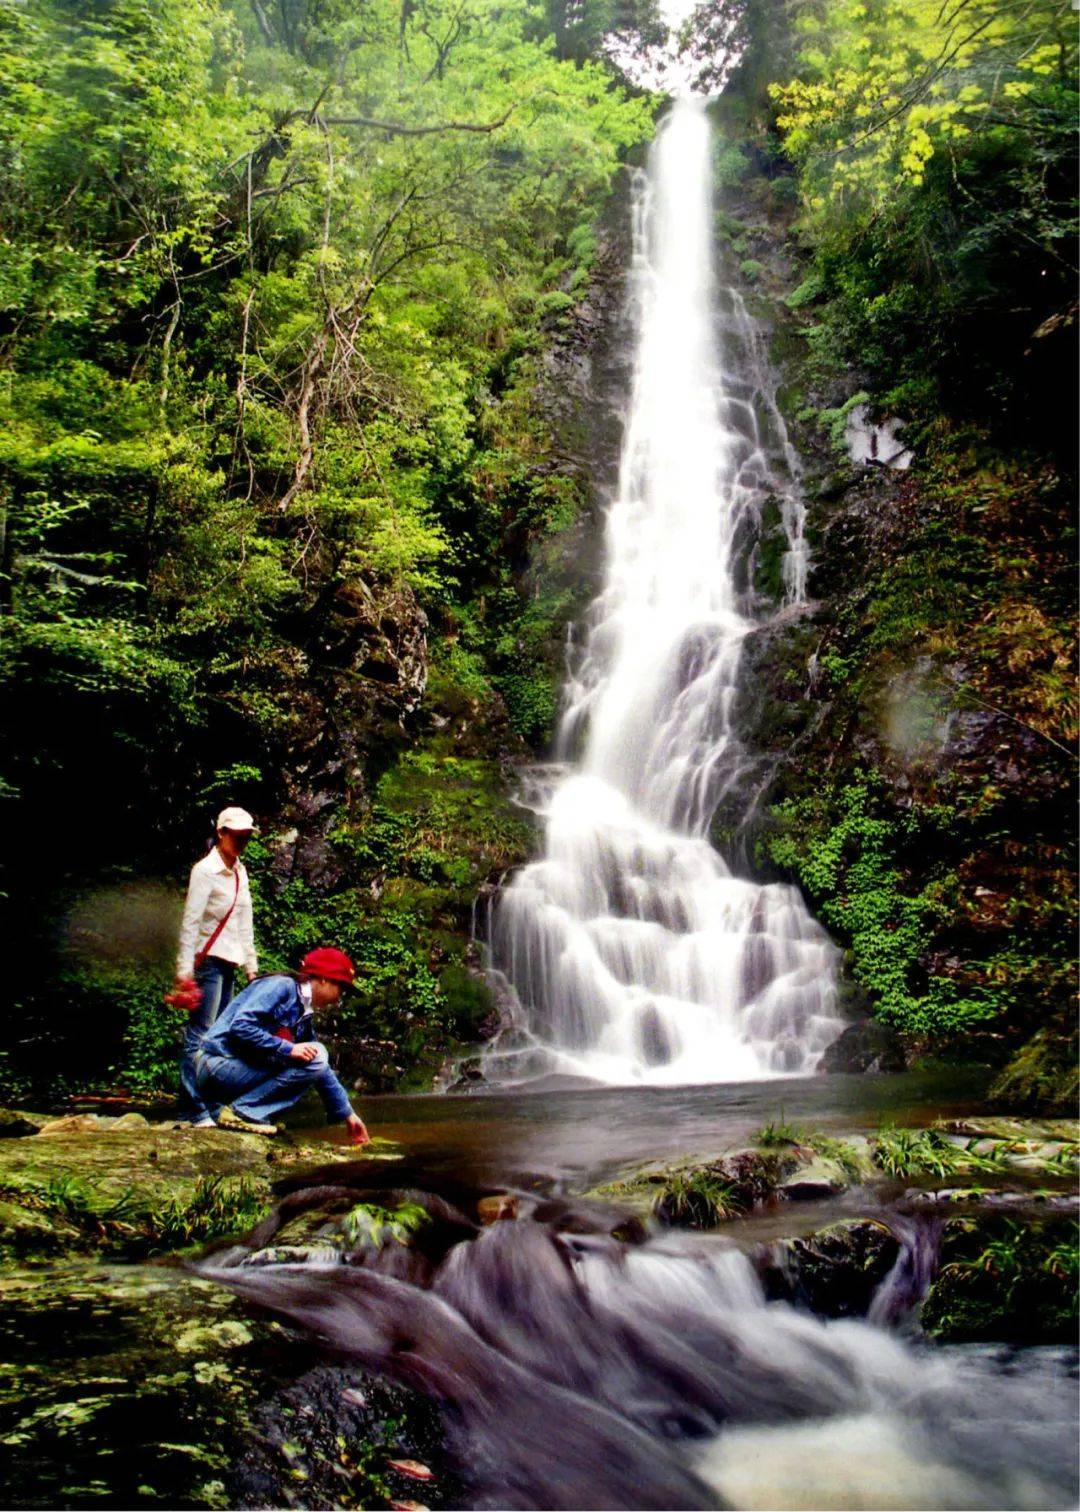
0;0;1077;1101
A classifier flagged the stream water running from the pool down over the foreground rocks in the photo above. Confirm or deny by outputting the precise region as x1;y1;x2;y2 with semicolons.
198;1077;1077;1509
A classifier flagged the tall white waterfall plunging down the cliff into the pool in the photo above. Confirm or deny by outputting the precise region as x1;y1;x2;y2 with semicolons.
487;98;841;1083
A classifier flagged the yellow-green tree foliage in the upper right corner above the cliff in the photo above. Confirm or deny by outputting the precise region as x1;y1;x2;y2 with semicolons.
755;0;1077;445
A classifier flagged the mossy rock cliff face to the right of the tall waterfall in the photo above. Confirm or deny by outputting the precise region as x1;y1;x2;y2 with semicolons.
714;130;1075;1104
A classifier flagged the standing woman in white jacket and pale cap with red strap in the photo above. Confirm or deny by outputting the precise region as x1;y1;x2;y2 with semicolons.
177;809;259;1129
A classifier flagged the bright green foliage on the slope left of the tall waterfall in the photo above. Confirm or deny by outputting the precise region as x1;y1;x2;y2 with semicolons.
0;0;655;1090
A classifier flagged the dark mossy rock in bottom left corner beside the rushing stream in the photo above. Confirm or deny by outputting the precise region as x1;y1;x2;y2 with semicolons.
0;1264;445;1507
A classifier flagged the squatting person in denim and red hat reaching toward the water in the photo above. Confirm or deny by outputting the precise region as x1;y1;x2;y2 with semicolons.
195;945;369;1145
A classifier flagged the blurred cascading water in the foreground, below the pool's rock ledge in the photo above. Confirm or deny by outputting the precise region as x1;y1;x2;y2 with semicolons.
198;1166;1075;1512
